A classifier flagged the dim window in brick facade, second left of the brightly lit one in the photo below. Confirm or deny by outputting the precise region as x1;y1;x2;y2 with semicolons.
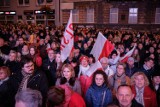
87;8;94;23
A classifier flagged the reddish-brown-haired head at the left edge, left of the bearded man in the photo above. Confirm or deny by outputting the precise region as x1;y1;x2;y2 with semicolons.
0;66;11;80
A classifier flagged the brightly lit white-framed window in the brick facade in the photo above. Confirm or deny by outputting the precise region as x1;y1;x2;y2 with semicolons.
128;8;138;24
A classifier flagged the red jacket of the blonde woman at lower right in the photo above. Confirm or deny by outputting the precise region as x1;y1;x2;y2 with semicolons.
132;86;158;107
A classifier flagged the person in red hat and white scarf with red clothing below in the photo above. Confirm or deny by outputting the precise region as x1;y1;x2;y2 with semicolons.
78;55;92;96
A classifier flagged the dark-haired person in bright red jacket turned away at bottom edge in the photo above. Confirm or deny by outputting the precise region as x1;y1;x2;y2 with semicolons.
47;85;86;107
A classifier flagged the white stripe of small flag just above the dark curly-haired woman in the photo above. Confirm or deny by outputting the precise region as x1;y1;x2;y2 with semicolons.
86;61;102;77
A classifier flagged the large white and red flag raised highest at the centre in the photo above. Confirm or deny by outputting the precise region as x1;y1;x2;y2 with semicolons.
90;32;114;60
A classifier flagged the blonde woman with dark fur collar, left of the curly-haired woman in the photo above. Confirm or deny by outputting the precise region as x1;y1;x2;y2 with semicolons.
56;64;81;95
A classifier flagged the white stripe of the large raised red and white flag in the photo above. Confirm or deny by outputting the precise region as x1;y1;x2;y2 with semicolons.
90;32;107;61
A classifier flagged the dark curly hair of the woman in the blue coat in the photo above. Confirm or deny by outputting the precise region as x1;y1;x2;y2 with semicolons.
92;70;108;86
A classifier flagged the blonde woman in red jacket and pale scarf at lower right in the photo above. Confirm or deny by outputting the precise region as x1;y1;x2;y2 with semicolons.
131;72;158;107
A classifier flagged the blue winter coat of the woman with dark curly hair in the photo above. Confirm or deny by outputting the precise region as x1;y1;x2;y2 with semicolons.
85;83;112;107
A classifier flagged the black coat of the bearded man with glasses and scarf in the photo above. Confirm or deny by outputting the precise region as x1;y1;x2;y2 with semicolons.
11;70;48;106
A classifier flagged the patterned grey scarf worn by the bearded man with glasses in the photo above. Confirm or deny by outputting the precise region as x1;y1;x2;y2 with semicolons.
18;70;32;91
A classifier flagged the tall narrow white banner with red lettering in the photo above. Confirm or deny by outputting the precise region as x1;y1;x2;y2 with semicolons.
61;11;74;62
